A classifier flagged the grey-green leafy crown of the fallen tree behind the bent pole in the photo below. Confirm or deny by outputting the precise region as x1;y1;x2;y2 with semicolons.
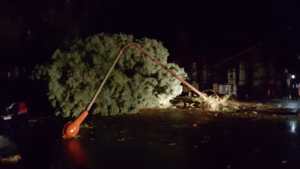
34;34;186;117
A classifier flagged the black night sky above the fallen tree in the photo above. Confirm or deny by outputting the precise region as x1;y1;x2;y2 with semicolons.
0;0;300;68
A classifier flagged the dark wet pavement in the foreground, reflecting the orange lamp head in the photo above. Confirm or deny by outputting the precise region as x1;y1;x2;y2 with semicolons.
1;116;300;169
